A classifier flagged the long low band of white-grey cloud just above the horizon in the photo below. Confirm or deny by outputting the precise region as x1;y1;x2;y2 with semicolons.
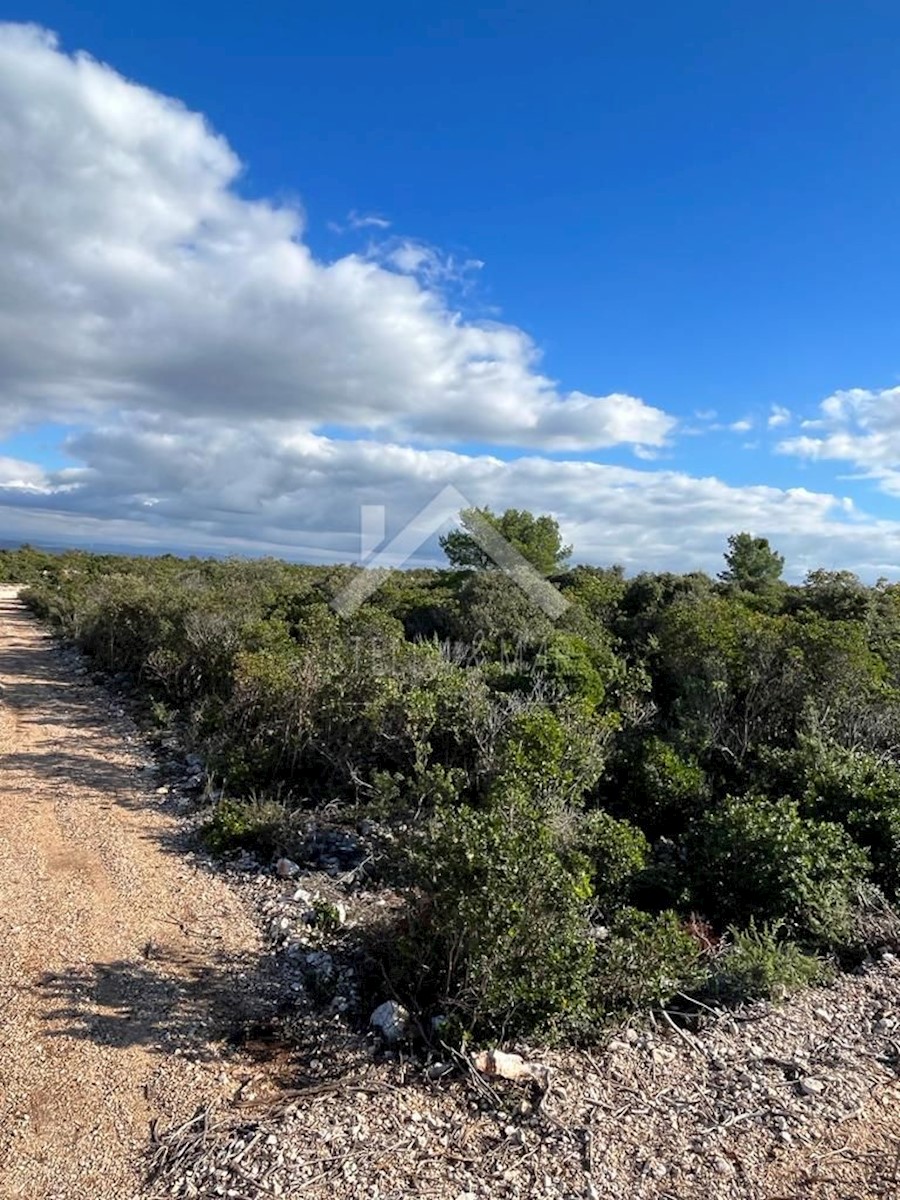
0;414;900;578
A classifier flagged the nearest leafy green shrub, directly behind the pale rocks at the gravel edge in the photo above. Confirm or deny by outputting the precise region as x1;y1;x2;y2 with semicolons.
391;788;594;1038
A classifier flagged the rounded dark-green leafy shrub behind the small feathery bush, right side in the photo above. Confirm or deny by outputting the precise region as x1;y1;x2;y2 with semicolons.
689;796;869;946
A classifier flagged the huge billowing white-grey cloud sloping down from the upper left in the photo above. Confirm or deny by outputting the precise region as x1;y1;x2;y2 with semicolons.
0;25;674;449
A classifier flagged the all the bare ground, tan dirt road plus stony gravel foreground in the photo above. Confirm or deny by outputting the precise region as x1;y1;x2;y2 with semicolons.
0;583;900;1200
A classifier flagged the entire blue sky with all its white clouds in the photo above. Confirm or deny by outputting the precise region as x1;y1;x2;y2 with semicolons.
0;0;900;580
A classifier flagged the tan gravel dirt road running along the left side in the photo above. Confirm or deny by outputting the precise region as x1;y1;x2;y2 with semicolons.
0;589;266;1200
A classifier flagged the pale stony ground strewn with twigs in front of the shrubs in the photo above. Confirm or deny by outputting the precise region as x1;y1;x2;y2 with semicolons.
142;961;900;1200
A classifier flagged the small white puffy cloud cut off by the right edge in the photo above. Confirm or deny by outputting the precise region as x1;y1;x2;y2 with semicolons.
778;388;900;496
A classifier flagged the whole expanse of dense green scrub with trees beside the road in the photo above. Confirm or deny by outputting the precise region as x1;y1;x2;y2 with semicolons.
0;520;900;1040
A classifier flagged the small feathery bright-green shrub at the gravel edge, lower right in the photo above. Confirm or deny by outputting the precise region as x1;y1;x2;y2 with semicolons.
709;919;828;1003
